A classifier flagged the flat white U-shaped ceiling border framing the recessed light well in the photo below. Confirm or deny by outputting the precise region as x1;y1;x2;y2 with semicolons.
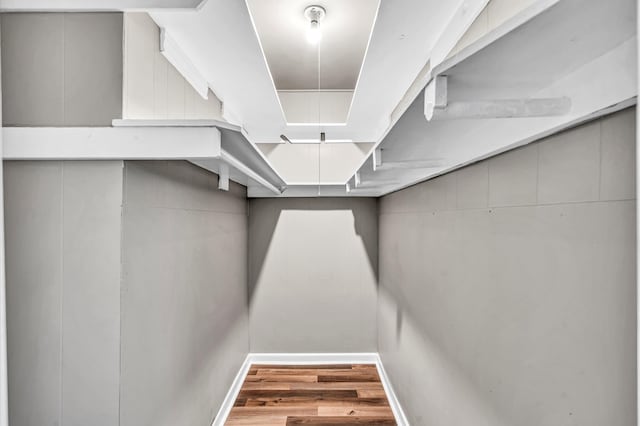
152;0;463;143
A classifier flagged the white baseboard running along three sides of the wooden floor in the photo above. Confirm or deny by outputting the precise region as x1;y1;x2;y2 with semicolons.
212;352;409;426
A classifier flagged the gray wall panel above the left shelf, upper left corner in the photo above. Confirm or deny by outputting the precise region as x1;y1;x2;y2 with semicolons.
1;13;123;126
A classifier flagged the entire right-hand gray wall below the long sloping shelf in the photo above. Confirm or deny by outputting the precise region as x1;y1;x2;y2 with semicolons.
378;109;636;426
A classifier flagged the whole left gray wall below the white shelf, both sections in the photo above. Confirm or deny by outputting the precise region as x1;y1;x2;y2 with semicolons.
4;161;249;426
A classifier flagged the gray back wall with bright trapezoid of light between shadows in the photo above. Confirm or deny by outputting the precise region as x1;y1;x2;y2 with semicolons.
249;198;378;352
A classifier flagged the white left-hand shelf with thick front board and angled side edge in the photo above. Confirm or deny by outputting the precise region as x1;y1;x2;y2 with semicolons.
1;125;282;195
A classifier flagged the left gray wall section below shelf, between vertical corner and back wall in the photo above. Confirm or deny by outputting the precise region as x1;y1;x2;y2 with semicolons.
120;161;249;426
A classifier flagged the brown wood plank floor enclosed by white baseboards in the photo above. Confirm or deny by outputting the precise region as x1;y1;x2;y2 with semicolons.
226;364;396;426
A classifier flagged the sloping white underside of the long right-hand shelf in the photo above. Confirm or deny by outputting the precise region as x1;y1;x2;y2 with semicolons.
340;0;637;196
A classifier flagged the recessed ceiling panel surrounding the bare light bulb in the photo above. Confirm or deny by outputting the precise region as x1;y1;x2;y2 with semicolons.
247;0;379;90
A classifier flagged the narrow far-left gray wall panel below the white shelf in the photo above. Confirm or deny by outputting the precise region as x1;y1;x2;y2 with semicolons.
4;161;122;426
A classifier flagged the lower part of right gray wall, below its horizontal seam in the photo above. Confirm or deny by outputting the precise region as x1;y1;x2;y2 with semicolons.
378;201;636;426
